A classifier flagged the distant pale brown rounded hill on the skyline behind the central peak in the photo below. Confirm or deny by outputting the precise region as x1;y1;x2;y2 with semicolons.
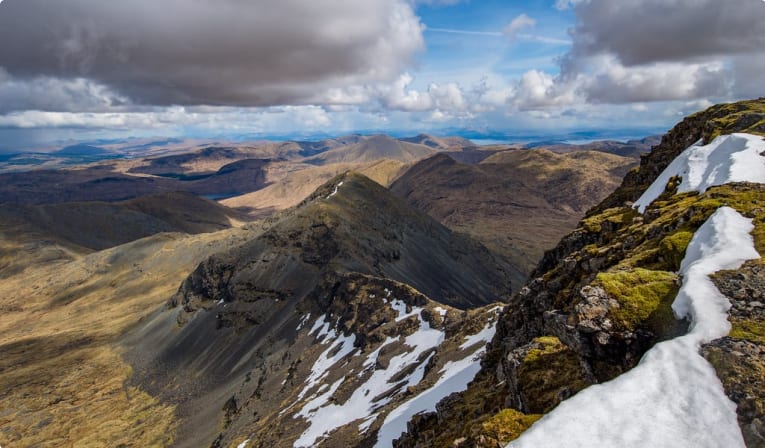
305;135;436;165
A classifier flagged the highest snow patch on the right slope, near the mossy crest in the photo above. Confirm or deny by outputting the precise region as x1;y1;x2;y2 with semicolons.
633;133;765;213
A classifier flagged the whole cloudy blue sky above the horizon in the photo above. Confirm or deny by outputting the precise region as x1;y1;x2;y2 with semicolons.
0;0;765;151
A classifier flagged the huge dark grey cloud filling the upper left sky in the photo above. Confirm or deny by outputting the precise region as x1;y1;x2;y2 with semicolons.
0;0;423;108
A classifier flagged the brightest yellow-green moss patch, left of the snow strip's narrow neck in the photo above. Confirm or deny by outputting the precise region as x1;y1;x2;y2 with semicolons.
595;268;679;330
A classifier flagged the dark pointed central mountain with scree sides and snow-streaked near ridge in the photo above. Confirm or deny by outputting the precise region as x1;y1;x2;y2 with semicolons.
126;173;517;446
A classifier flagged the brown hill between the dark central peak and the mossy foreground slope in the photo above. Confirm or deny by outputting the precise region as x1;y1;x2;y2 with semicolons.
391;150;633;272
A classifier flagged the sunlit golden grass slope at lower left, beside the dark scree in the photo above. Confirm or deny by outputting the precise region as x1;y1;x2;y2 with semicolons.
0;229;251;447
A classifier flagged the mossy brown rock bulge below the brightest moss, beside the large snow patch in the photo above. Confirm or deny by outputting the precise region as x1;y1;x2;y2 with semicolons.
518;336;590;414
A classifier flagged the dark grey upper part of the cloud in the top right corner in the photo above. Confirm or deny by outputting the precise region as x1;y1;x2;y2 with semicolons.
572;0;765;66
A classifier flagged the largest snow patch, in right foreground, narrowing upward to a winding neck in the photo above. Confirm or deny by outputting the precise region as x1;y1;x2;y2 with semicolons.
508;207;760;448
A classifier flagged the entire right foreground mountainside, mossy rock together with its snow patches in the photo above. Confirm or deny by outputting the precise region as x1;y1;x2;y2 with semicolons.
396;100;765;447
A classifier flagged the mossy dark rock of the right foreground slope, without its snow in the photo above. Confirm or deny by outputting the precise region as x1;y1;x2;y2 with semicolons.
396;100;765;447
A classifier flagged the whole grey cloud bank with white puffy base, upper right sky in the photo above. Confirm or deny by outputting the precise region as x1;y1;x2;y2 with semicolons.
540;0;765;105
